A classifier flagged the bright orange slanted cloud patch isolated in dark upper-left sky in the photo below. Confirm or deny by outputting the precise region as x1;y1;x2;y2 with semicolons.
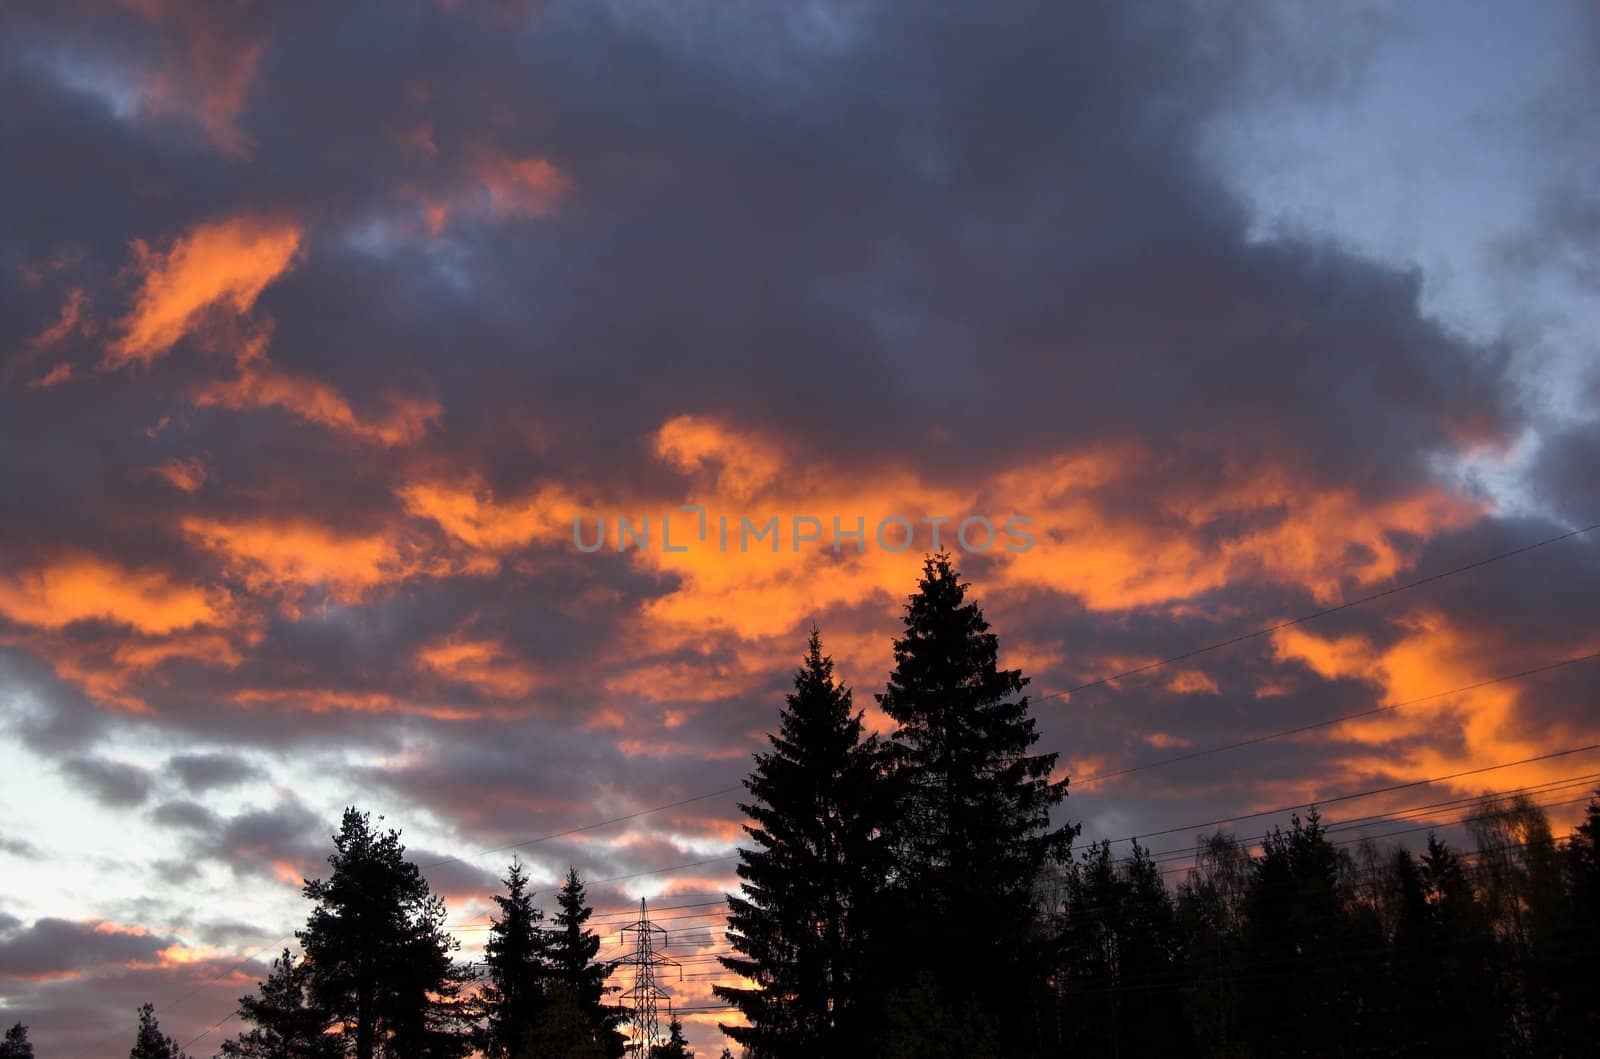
102;216;302;370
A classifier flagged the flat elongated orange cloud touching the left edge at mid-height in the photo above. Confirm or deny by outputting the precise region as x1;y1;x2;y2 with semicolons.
0;555;221;635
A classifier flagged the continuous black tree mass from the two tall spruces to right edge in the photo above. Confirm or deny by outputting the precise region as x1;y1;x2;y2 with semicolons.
717;555;1600;1059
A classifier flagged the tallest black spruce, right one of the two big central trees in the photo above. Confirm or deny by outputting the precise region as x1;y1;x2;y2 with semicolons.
878;555;1077;1054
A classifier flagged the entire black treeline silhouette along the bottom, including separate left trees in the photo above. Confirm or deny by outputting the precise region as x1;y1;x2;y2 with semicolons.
0;555;1600;1059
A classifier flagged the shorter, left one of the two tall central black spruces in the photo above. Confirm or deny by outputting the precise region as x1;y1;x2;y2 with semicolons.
715;629;888;1059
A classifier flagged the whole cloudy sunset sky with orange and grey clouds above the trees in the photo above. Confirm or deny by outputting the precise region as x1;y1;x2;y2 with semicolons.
0;0;1600;1059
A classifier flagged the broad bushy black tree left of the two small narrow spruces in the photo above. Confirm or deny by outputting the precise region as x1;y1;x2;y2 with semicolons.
299;808;470;1059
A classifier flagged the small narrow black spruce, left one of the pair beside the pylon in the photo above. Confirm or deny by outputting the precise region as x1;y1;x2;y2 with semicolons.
474;861;550;1059
